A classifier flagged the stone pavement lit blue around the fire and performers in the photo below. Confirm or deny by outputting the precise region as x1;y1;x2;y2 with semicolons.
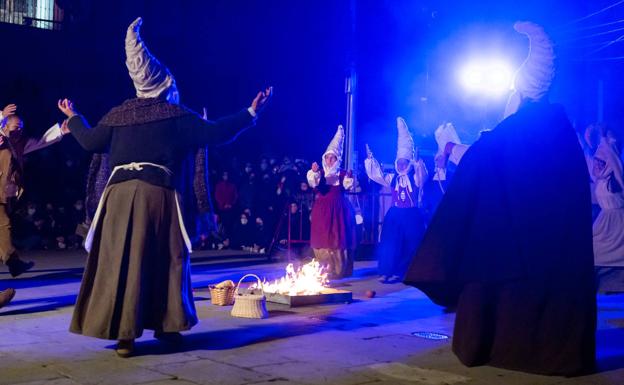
0;252;624;385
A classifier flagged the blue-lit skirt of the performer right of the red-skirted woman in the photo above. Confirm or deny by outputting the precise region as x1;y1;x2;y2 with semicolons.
377;207;425;279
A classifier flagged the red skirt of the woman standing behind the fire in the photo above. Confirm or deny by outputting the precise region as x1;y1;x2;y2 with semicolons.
310;186;356;250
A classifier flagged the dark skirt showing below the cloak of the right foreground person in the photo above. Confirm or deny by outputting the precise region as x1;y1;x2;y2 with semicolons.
453;277;596;376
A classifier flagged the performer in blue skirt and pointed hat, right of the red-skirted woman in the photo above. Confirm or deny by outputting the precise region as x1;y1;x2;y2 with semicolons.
364;117;428;283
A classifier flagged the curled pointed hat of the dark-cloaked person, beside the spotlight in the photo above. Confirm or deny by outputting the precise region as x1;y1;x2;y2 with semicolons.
505;21;555;117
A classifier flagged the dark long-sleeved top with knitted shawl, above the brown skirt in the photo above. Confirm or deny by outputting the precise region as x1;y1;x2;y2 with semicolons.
68;99;253;188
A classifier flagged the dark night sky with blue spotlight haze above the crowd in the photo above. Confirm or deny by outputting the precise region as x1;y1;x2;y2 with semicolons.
0;0;624;168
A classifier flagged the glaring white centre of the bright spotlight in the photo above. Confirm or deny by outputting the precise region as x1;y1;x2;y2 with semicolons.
459;59;513;97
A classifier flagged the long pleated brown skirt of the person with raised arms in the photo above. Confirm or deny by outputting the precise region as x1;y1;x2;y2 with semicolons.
70;179;197;340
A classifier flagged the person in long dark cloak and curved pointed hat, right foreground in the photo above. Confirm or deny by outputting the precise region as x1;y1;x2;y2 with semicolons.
405;22;596;376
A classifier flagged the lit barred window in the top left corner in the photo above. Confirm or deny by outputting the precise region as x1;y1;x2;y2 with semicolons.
0;0;63;30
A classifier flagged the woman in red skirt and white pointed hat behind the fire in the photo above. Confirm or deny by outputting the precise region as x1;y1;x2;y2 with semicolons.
307;125;356;279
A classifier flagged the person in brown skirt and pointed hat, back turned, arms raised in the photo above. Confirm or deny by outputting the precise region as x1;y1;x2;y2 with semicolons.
58;18;272;357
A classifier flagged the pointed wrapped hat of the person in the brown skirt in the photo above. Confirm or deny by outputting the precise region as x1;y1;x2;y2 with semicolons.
126;17;179;103
